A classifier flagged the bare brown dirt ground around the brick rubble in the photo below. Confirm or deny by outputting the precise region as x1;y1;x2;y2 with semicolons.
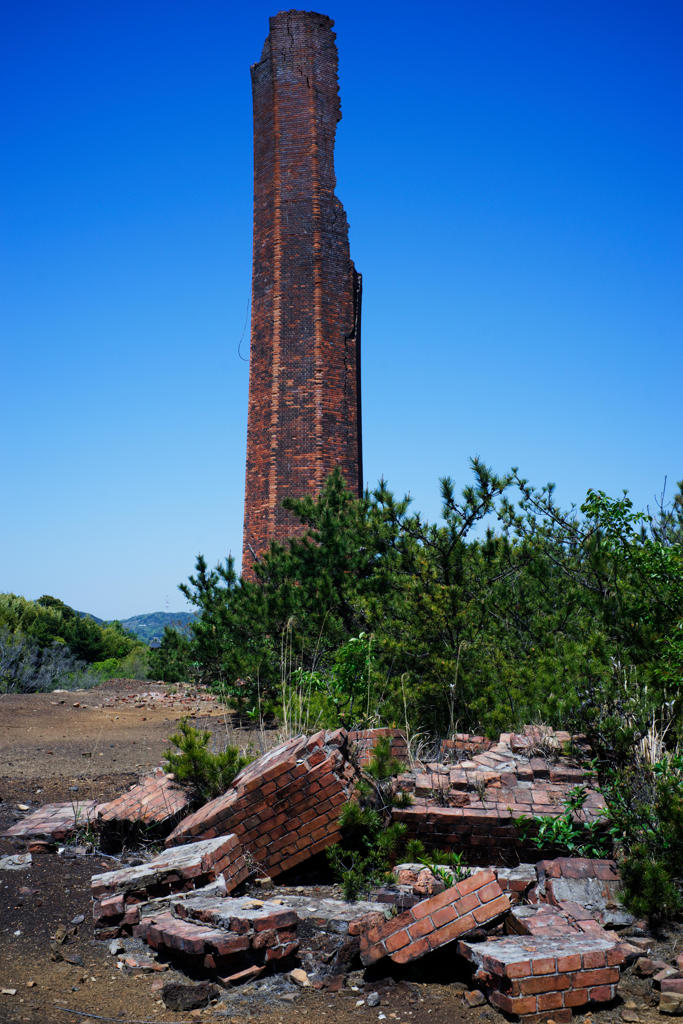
0;681;681;1024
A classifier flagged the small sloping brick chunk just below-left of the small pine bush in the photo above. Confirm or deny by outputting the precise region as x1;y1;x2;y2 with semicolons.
97;769;189;830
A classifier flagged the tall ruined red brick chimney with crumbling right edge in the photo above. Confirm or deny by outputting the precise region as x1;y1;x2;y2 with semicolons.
242;10;362;578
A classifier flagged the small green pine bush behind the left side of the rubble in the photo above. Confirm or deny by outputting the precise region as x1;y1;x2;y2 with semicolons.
164;718;251;801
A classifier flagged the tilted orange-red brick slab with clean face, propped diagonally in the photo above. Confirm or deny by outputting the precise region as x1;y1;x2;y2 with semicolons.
360;870;510;967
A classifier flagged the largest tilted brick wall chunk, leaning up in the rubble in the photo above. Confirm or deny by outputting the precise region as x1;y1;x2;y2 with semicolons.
167;729;355;877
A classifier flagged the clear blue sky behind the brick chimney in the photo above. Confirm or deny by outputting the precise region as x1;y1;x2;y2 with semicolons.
0;0;683;617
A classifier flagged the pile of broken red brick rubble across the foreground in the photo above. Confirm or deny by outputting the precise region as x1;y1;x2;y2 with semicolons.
5;729;683;1024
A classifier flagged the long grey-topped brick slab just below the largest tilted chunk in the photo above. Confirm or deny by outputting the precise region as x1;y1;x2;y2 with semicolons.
90;836;249;939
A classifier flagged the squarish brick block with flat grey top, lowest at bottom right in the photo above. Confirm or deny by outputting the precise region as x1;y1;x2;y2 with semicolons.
458;935;624;1024
